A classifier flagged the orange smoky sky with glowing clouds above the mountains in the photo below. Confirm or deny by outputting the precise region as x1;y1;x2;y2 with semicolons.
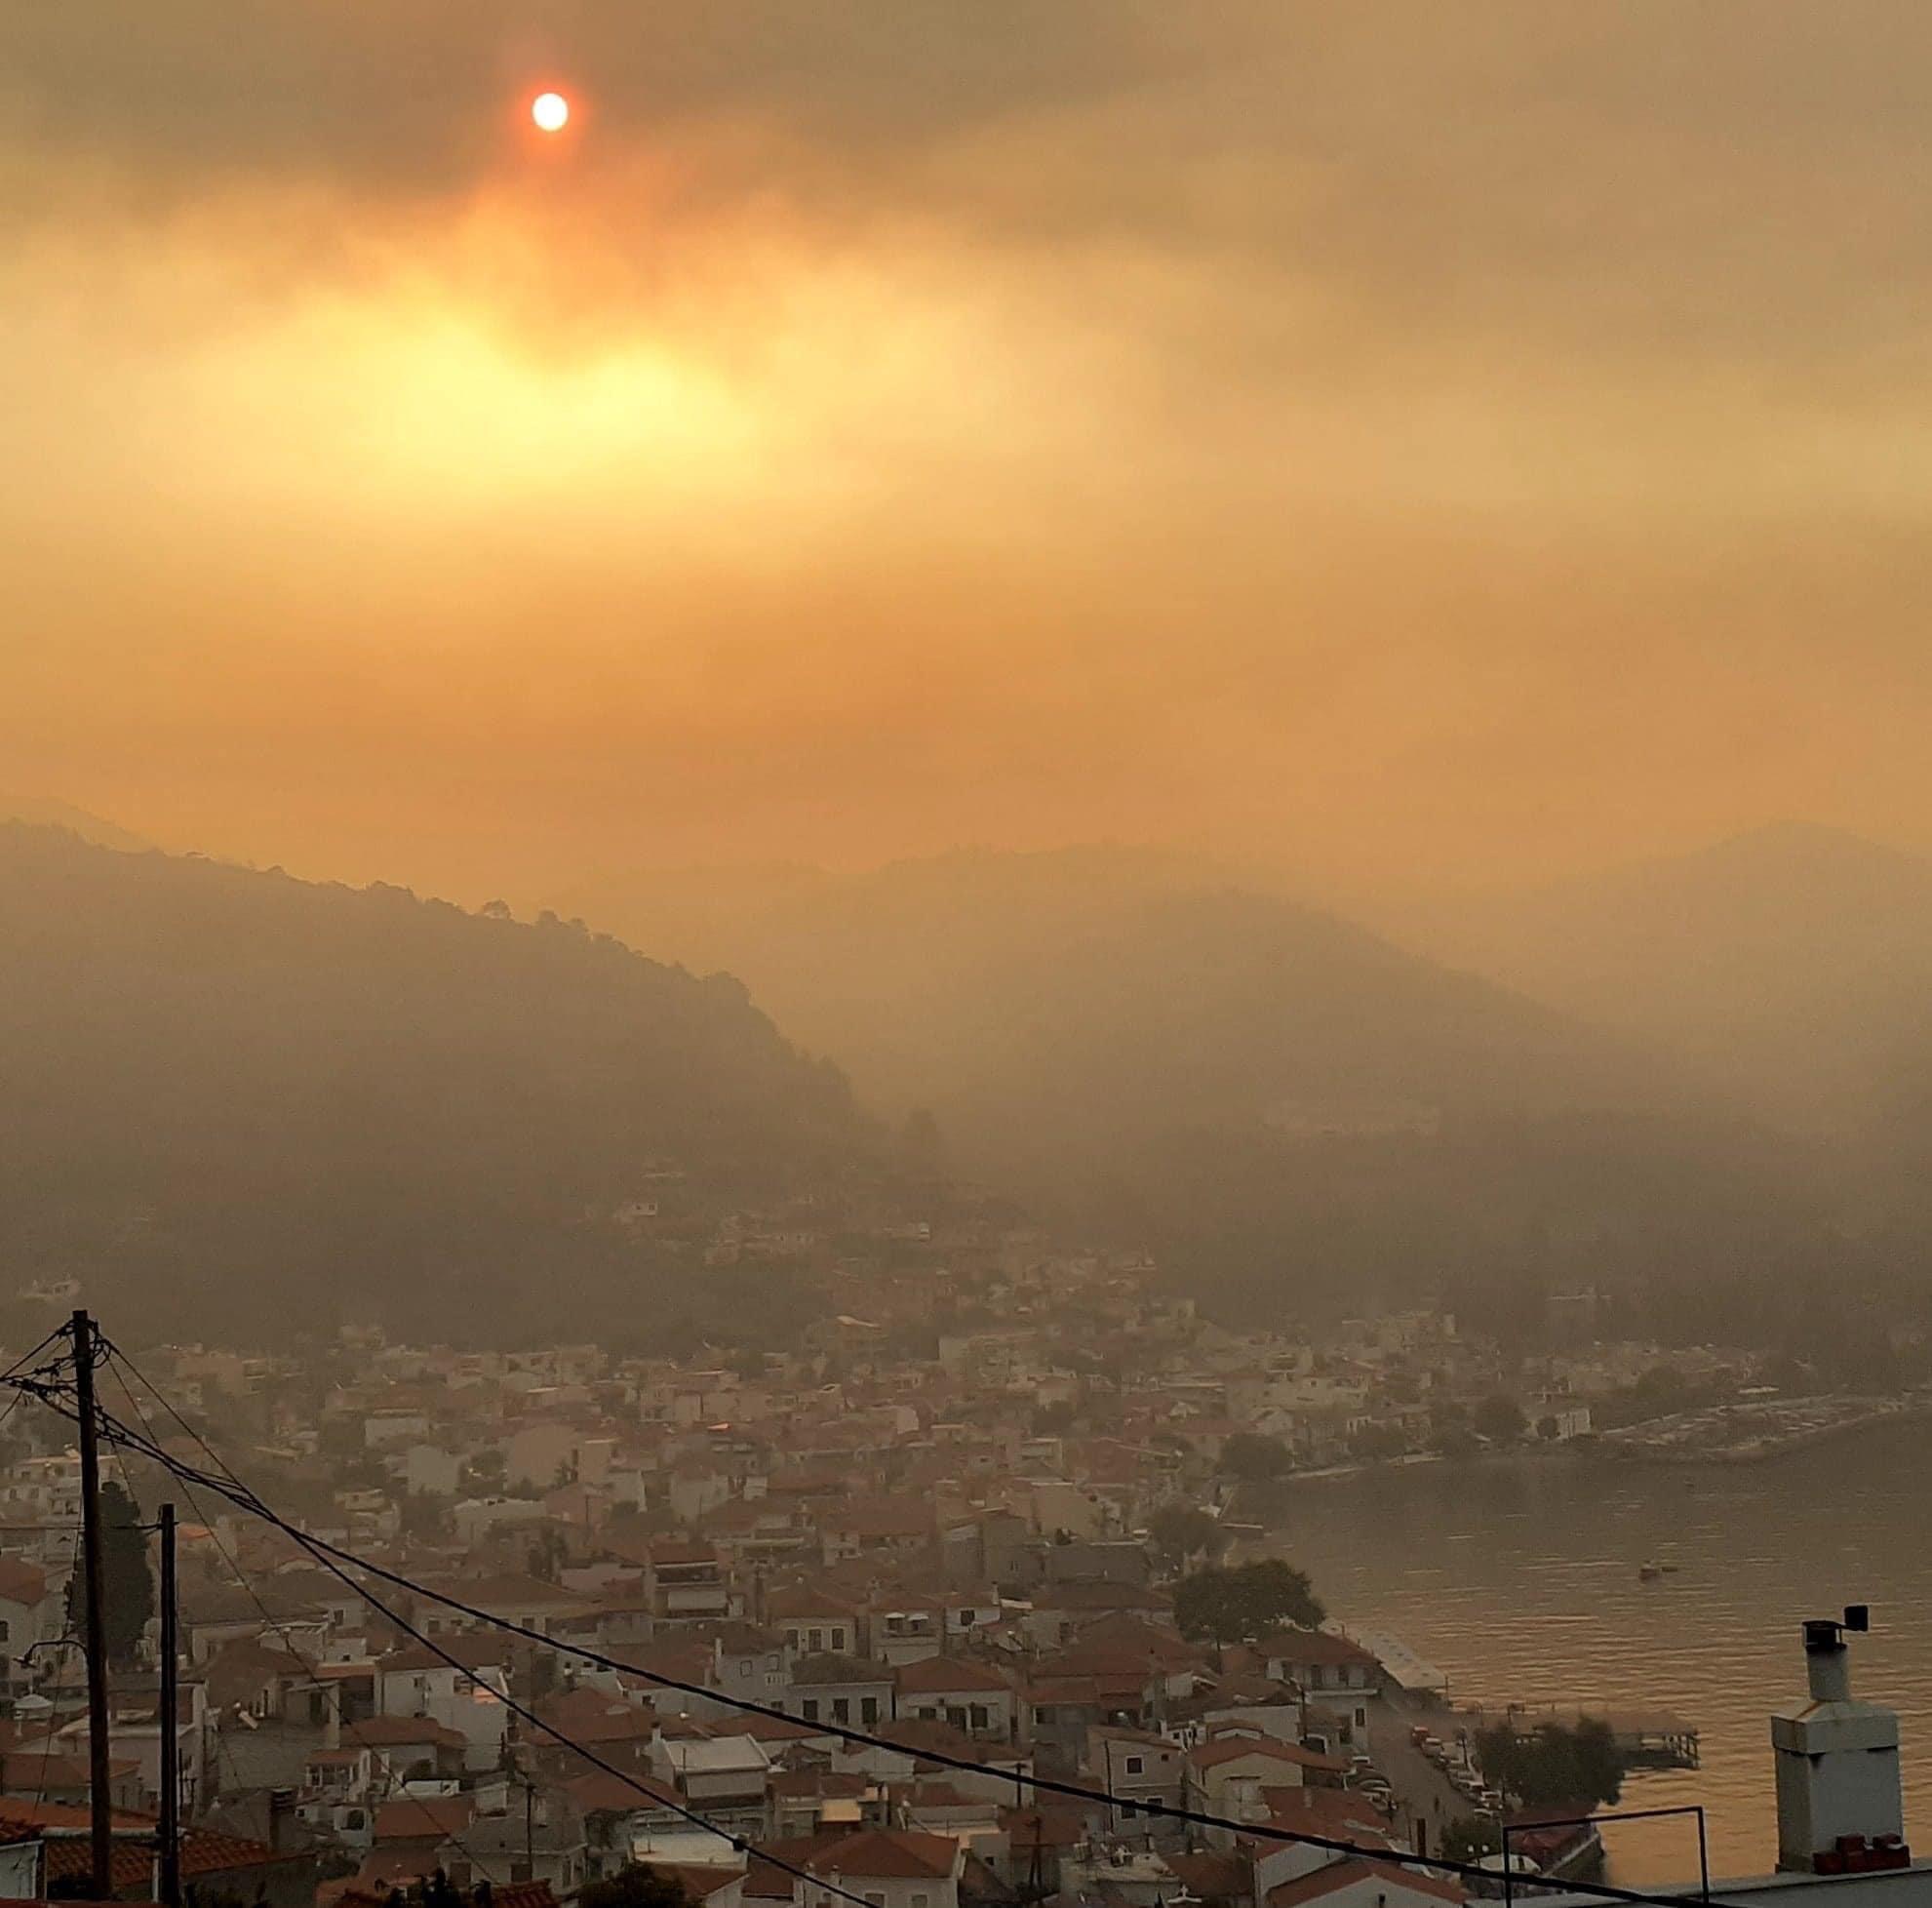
0;0;1932;899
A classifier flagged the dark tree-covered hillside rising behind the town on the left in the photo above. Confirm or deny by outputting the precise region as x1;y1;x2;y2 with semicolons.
0;823;869;1337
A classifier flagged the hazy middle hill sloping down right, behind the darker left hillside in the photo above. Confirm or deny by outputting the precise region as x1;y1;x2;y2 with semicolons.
573;849;1838;1337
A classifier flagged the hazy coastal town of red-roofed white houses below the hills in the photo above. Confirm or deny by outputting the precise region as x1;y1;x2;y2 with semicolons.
0;1211;1905;1908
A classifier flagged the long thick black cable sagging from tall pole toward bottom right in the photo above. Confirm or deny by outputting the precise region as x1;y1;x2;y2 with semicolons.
14;1380;1706;1908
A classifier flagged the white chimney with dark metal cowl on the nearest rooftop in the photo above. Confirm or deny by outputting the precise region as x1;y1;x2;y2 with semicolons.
1772;1605;1911;1875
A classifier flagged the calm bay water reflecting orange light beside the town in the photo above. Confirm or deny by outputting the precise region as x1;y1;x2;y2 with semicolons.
1268;1423;1932;1885
